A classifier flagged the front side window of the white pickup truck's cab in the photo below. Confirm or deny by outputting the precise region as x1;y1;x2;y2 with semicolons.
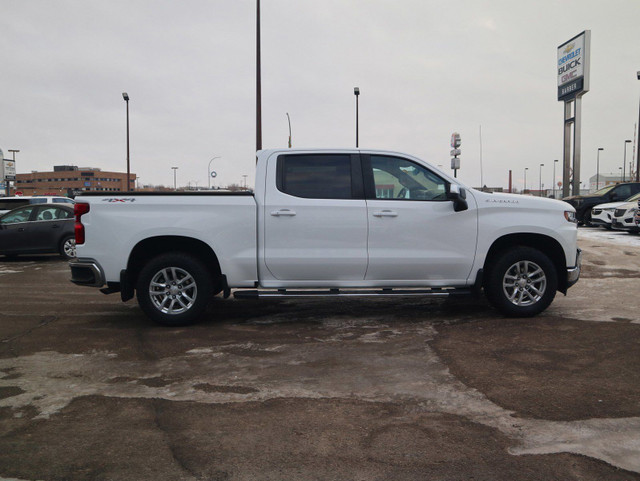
371;155;447;201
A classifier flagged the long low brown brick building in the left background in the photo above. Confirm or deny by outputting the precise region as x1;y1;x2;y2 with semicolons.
12;165;136;195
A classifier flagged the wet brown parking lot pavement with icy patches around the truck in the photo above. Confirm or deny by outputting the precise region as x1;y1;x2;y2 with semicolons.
0;229;640;481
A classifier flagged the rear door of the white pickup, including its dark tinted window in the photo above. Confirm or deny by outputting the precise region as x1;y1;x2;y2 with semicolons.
263;153;367;281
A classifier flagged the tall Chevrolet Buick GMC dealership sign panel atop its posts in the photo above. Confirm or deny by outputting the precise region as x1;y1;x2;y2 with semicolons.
557;30;591;102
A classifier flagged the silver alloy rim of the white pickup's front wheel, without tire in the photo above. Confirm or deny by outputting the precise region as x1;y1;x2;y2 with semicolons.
502;261;547;306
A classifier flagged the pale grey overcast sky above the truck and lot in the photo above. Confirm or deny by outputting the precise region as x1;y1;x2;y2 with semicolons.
0;0;640;188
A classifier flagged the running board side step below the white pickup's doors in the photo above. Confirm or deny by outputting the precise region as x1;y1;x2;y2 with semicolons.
233;288;472;299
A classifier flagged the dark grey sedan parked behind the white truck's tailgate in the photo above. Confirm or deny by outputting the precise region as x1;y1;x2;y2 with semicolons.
0;204;76;259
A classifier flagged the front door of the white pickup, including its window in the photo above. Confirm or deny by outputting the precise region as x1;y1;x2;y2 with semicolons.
362;155;477;286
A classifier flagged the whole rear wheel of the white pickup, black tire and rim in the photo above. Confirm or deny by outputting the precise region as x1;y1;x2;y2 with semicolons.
136;252;213;326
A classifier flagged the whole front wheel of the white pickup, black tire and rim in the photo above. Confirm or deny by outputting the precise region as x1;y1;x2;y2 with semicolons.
484;246;558;317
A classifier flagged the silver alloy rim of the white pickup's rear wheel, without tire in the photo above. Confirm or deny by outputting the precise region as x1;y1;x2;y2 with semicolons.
149;267;198;314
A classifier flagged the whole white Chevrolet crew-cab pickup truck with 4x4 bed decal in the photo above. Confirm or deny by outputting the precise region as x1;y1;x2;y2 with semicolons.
70;149;581;325
